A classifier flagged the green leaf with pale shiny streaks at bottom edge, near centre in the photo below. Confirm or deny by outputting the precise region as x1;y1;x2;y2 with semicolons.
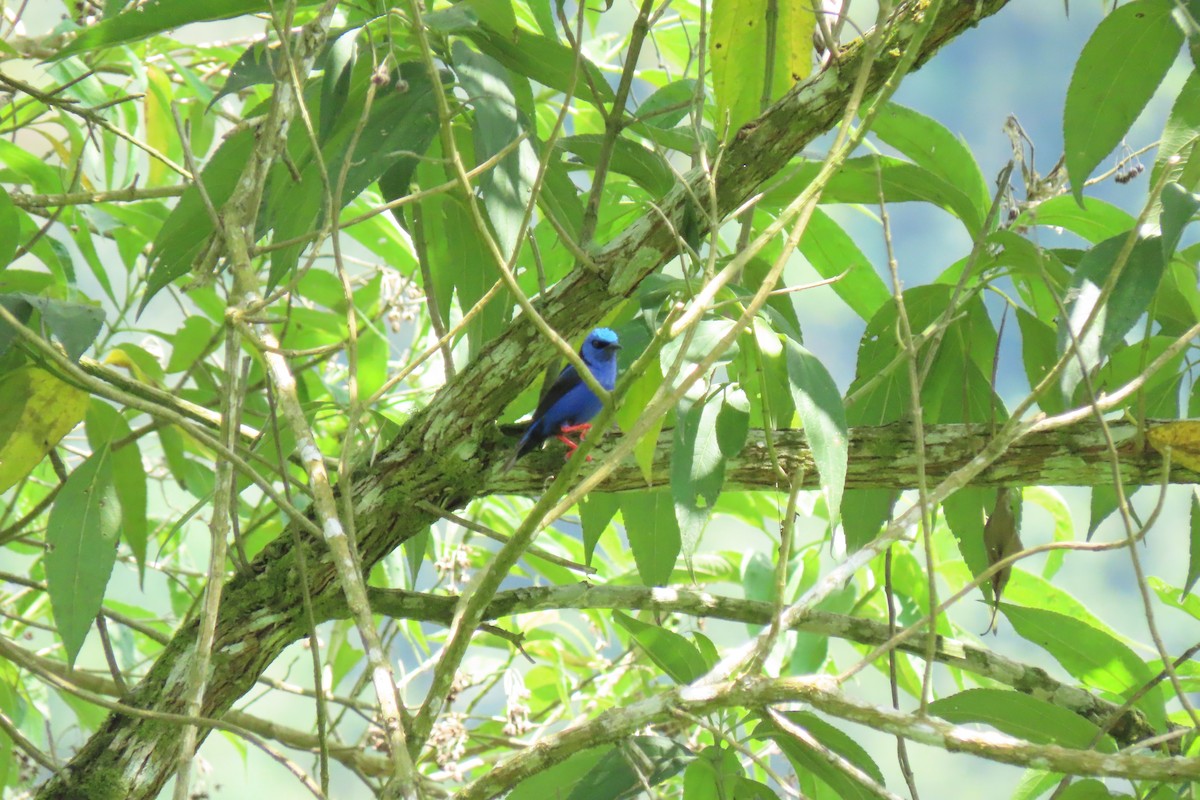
564;736;695;800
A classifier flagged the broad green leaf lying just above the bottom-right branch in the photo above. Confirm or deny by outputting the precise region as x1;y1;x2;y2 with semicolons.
929;688;1116;753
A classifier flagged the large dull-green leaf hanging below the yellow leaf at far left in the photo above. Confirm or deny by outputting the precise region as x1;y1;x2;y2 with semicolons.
46;445;121;666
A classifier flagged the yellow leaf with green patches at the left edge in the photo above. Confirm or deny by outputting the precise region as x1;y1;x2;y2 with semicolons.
0;367;88;492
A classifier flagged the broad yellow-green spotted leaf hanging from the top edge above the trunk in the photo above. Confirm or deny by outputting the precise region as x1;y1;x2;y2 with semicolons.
709;0;816;132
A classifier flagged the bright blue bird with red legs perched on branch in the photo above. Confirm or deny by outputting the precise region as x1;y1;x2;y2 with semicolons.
504;327;620;470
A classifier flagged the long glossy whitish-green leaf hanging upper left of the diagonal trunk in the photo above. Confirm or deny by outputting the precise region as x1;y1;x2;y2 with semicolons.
451;42;538;258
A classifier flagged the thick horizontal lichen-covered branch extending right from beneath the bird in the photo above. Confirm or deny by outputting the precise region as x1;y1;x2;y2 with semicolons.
487;421;1200;495
